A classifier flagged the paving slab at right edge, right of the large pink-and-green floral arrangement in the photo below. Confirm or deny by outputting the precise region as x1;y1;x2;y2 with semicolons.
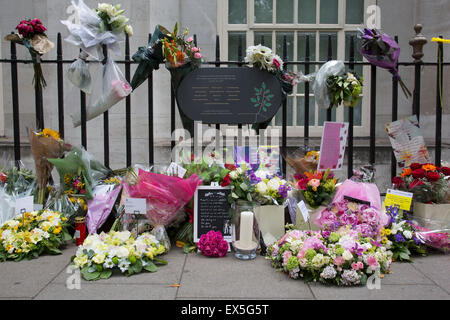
412;253;450;294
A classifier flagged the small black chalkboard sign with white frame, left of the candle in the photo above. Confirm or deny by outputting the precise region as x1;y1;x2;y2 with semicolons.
194;186;233;242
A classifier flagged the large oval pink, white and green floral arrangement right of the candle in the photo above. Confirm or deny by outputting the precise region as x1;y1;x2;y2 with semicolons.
267;227;392;286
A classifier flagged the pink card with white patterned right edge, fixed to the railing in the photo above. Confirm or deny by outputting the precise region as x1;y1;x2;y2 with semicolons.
317;121;348;171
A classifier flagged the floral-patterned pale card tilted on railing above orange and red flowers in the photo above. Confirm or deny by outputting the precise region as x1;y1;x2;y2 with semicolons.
386;115;431;168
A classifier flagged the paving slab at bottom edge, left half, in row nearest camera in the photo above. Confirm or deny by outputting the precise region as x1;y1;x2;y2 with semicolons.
35;281;177;300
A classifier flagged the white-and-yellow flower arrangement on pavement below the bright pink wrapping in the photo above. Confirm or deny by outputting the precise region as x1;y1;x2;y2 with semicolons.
72;231;167;281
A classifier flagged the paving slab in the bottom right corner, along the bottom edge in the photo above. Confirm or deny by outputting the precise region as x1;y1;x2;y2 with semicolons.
310;282;450;300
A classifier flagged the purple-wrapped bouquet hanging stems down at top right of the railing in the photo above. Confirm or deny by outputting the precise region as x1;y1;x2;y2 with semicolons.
359;28;411;97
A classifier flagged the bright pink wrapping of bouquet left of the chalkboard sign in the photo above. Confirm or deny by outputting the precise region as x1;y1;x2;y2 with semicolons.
124;169;201;248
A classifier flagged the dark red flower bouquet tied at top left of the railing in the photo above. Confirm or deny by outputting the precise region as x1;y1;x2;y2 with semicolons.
5;18;55;89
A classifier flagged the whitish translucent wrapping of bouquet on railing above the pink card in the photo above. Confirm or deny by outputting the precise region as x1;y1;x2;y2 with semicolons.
312;60;345;109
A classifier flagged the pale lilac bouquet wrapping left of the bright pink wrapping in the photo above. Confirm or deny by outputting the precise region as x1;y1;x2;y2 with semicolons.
86;185;122;234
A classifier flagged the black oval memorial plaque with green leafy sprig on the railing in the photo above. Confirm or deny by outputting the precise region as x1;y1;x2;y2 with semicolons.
177;67;282;124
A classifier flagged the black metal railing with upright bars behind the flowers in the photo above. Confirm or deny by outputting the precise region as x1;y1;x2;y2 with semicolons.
0;29;450;177
